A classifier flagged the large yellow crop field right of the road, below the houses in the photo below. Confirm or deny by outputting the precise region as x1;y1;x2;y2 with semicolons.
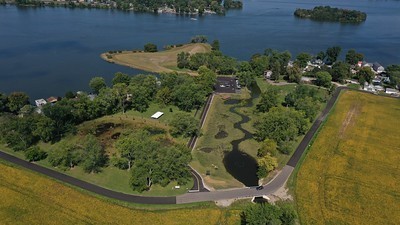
295;91;400;224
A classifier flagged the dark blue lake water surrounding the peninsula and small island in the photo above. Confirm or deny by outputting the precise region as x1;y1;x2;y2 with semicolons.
0;0;400;101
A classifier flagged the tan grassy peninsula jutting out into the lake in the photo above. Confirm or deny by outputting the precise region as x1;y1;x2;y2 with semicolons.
101;43;211;74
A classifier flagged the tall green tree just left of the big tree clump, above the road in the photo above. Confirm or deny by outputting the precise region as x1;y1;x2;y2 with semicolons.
81;135;107;173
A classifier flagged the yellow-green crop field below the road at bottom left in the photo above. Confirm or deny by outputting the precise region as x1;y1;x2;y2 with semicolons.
0;161;241;225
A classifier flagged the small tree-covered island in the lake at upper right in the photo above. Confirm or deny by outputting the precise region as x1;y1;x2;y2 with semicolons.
294;6;367;23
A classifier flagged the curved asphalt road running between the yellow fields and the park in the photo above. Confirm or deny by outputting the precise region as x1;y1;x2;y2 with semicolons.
0;87;347;204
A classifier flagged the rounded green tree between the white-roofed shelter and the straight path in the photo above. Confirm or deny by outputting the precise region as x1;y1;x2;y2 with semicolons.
170;113;199;137
